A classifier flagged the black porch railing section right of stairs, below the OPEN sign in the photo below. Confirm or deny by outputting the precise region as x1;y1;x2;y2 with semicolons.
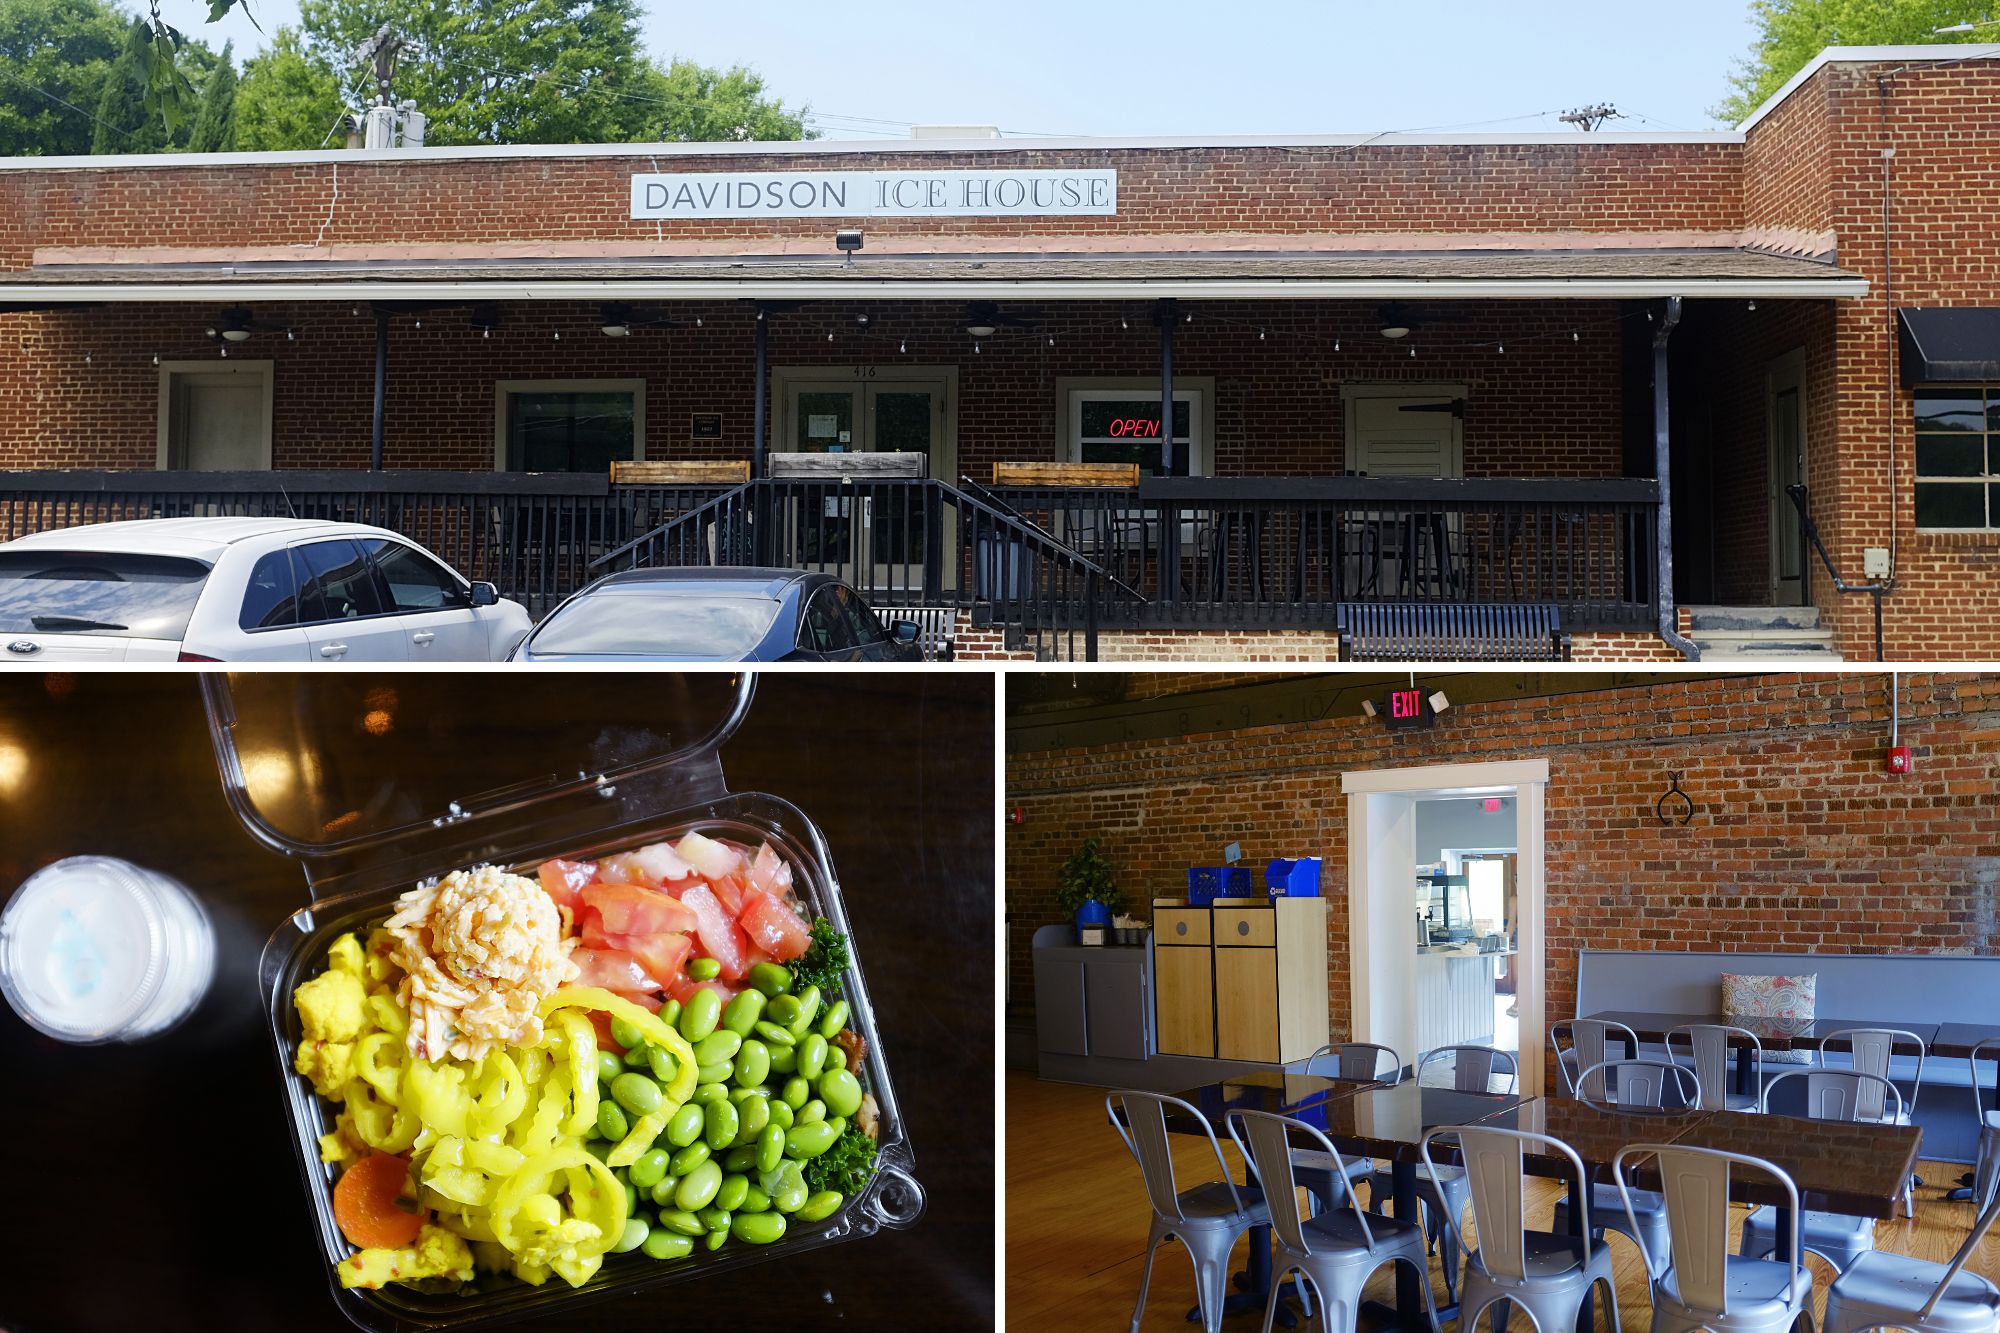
988;476;1660;630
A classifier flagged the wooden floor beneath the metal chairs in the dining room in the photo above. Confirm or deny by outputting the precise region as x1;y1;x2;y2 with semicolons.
1006;1071;2000;1333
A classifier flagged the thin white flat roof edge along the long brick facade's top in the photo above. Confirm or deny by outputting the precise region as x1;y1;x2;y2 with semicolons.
0;130;1744;172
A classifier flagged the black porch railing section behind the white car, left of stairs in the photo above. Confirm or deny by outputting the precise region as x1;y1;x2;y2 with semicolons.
0;470;726;616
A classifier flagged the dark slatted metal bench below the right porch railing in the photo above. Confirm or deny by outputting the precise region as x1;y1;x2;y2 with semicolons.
1334;602;1570;662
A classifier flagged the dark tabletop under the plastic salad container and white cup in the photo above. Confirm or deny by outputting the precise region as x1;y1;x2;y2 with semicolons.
0;673;996;1333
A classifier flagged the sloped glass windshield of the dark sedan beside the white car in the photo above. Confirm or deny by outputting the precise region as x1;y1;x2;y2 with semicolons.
528;588;782;658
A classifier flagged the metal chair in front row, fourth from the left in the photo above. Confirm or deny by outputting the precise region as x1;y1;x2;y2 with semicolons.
1612;1143;1812;1333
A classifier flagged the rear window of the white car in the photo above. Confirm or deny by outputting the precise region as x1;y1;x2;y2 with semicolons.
0;550;208;638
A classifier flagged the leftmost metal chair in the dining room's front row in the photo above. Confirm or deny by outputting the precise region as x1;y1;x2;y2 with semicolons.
1104;1091;1270;1333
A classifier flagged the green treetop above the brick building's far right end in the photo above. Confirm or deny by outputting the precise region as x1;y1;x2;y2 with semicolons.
1710;0;2000;124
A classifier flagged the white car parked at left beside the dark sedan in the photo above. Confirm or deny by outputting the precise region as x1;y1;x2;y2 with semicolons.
0;518;532;664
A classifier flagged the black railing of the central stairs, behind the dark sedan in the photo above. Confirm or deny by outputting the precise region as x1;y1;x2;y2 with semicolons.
592;478;1144;660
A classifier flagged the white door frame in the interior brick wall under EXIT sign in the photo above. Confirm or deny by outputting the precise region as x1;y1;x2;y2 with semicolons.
1340;759;1548;1097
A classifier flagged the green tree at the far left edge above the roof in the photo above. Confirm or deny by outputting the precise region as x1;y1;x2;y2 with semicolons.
0;0;130;158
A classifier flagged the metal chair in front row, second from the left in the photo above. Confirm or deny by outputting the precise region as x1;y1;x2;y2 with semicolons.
1228;1111;1438;1333
